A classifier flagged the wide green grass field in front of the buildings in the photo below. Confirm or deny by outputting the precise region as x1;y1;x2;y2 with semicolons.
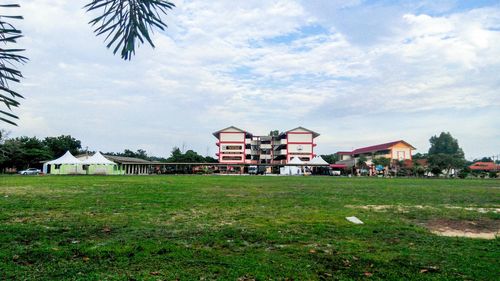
0;176;500;280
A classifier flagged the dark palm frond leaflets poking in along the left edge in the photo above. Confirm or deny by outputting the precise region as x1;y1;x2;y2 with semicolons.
0;4;28;126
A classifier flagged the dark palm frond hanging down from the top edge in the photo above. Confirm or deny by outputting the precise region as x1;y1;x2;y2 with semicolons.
85;0;175;60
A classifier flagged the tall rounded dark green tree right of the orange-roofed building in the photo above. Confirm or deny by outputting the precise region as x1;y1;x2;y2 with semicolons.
428;132;465;176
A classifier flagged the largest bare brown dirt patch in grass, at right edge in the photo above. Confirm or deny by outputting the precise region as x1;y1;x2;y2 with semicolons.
425;219;500;239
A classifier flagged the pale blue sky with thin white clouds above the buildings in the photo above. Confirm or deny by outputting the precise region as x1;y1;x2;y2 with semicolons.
2;0;500;159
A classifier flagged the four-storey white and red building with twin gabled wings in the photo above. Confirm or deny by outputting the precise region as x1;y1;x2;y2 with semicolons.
213;126;319;164
